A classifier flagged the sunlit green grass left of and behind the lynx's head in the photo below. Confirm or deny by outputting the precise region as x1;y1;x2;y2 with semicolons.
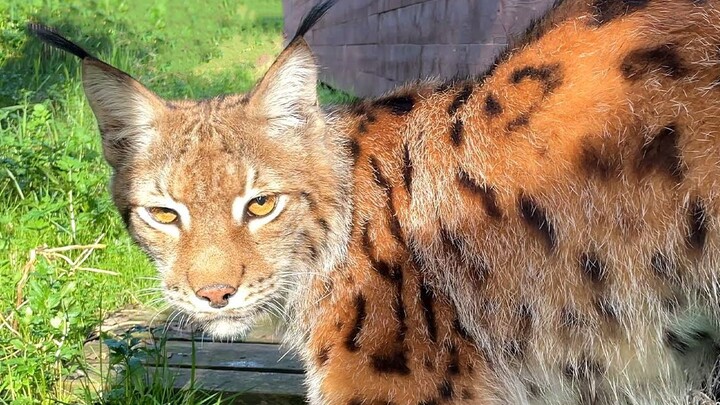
0;0;348;404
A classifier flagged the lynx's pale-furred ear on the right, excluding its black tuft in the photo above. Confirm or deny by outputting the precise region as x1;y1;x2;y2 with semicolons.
250;38;319;135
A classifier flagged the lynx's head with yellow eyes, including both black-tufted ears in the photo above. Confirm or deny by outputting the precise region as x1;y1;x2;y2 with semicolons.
30;1;350;337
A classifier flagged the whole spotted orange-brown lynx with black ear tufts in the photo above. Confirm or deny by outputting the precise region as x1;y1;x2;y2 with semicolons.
31;0;720;405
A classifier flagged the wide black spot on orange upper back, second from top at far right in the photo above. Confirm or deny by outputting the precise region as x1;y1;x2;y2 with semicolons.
620;45;688;81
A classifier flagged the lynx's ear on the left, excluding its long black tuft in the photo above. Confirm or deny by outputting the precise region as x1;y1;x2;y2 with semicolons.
83;58;166;169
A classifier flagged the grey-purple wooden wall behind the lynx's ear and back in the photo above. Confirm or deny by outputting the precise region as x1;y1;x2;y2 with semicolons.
283;0;552;96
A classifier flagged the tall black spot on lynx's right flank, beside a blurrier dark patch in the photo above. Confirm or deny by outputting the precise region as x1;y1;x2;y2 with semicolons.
638;124;684;182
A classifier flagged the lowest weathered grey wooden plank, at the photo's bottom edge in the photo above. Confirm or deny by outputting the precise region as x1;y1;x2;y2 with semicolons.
148;367;306;404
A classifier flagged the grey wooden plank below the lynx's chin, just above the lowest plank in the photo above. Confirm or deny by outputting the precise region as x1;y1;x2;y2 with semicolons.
149;341;304;374
